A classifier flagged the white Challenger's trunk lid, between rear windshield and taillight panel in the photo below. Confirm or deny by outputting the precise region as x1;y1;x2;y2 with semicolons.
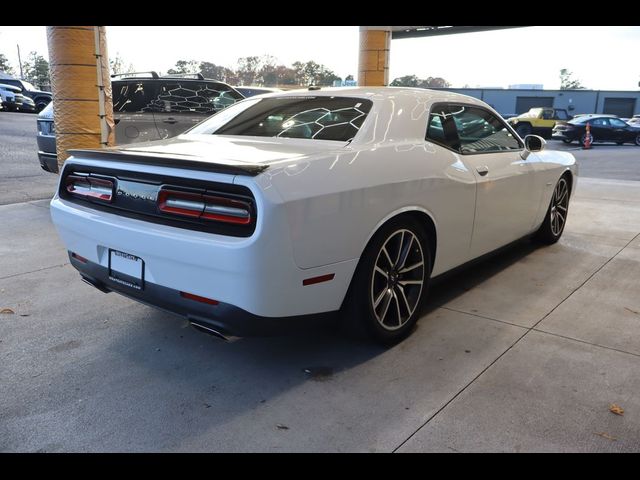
70;134;345;175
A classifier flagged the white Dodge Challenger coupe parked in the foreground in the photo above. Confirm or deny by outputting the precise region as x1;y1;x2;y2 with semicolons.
51;87;577;344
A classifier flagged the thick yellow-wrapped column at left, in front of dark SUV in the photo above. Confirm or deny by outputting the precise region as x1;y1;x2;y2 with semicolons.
47;26;115;171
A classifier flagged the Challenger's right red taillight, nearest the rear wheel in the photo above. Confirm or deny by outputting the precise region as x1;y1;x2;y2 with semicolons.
158;189;251;225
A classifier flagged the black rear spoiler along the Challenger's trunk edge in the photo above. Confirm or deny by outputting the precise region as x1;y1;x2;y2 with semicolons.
69;149;269;177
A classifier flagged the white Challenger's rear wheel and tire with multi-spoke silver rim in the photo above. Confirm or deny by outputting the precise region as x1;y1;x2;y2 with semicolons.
343;217;431;346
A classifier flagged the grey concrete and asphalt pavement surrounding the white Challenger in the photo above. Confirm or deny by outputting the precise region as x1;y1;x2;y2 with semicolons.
0;112;640;452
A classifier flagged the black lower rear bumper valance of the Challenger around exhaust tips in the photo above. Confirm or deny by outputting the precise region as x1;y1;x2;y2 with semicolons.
69;252;335;337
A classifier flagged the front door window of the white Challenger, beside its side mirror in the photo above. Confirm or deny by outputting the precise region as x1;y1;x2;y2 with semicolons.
450;105;522;153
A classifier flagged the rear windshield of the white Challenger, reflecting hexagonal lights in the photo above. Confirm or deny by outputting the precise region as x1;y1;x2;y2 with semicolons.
189;96;372;142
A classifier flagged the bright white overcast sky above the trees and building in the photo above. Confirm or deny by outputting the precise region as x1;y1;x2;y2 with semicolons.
0;26;640;90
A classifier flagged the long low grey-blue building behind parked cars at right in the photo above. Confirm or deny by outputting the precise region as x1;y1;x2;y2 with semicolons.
438;88;640;118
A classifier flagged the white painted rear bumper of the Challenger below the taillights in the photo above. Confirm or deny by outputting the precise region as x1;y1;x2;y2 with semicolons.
51;195;358;322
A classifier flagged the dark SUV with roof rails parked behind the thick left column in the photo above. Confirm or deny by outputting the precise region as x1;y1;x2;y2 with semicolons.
36;72;244;173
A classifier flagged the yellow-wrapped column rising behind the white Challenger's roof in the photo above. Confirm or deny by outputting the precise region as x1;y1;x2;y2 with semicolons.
358;27;391;87
